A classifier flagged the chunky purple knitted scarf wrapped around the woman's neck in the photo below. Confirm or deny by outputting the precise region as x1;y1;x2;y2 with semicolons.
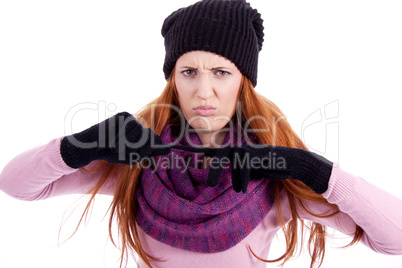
137;122;273;253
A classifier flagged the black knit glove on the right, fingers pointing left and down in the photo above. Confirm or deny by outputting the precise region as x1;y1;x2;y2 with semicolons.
173;145;333;194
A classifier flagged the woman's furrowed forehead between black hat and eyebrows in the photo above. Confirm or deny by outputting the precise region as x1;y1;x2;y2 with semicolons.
177;50;236;67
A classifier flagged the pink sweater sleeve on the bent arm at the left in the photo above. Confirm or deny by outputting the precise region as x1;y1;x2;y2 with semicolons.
0;138;114;201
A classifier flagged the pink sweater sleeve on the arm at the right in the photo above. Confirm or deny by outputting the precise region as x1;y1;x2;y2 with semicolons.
300;165;402;254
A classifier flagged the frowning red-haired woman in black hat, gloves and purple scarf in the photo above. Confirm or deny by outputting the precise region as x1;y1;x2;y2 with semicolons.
0;1;402;267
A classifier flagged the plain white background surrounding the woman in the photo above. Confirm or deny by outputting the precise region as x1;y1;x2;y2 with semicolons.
0;0;402;268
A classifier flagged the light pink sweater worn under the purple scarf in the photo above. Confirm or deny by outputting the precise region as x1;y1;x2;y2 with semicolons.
0;138;402;268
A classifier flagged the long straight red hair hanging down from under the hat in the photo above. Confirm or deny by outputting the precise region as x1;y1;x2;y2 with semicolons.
78;70;363;267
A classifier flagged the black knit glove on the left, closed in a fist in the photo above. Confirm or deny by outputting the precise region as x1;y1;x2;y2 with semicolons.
60;112;170;168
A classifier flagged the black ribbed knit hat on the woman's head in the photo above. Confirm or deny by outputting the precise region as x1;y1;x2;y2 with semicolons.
162;0;264;86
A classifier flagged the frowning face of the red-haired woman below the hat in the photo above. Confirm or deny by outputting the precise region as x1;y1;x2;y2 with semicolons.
174;51;242;141
